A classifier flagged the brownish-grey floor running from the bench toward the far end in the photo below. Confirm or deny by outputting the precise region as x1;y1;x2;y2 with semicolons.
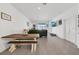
0;36;79;55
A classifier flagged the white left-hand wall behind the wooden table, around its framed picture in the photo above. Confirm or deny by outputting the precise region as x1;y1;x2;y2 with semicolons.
0;3;32;52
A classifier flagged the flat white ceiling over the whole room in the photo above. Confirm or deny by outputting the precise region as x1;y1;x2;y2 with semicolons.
12;3;76;23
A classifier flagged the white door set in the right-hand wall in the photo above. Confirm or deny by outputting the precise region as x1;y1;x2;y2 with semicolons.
64;18;76;43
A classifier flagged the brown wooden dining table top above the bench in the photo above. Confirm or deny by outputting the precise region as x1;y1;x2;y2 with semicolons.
1;34;39;39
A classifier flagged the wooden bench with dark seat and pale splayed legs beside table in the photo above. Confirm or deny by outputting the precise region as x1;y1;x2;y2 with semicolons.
8;39;37;53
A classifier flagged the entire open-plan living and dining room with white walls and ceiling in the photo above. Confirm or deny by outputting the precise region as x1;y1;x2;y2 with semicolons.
0;3;79;55
